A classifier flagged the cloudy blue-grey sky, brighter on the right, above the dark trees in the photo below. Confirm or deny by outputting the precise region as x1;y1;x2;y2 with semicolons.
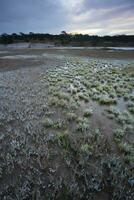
0;0;134;35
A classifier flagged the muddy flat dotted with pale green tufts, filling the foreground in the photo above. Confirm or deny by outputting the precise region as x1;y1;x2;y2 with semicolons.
0;49;134;200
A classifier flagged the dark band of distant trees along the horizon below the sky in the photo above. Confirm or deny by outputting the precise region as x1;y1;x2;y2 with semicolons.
0;31;134;47
